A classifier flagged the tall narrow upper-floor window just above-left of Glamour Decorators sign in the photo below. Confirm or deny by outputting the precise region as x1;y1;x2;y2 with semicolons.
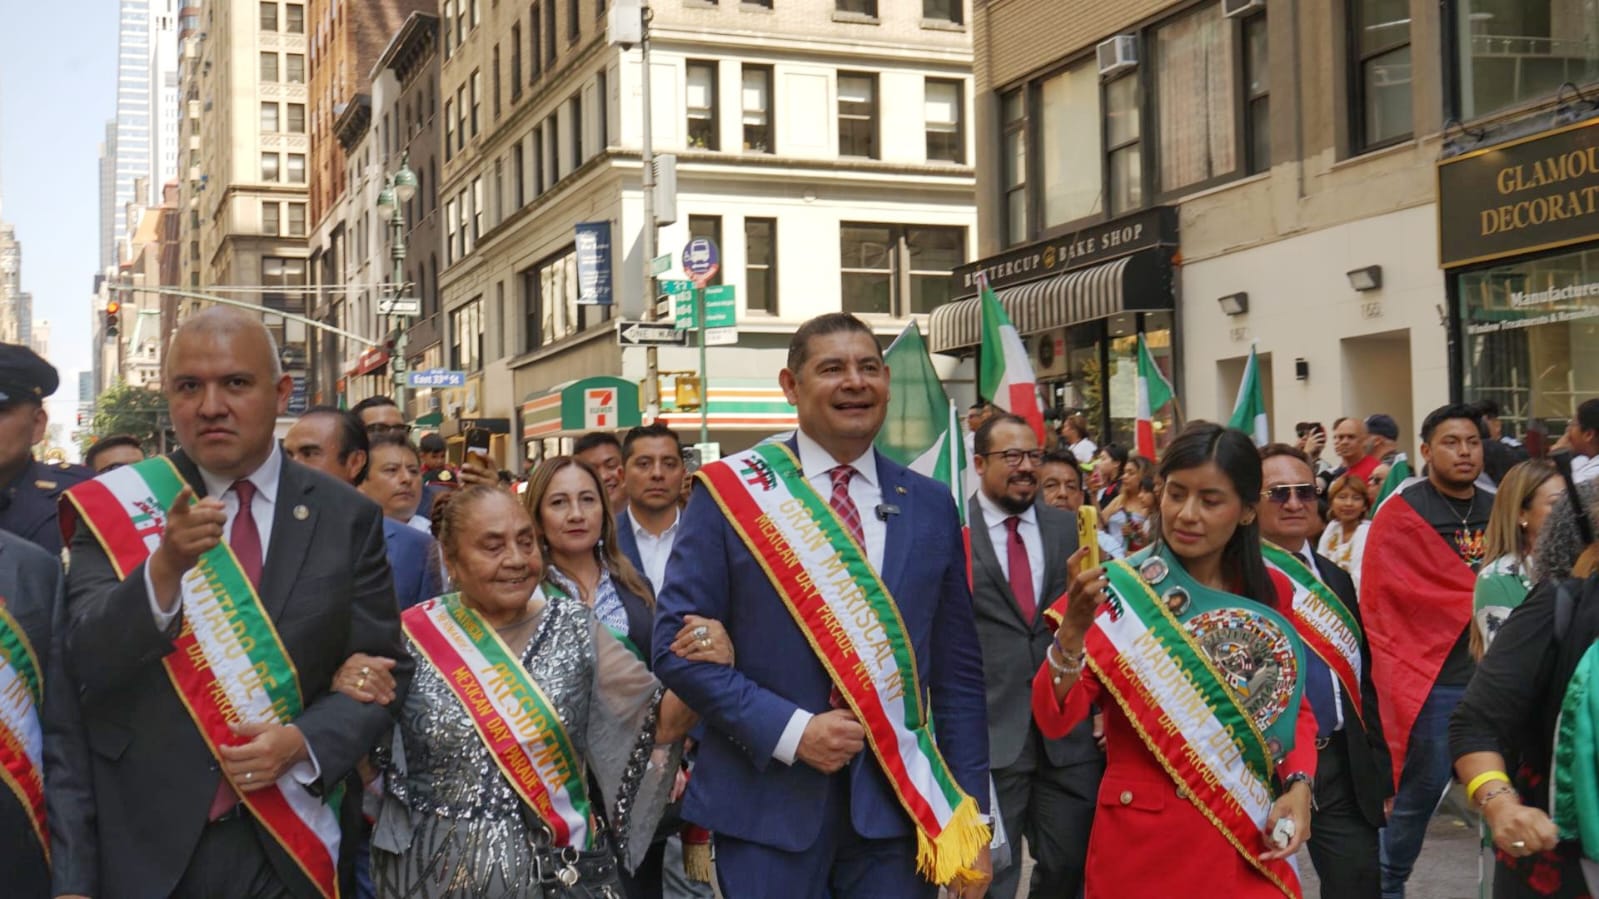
1350;0;1413;152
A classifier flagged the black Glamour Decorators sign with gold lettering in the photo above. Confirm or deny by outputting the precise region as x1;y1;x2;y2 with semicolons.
1438;118;1599;269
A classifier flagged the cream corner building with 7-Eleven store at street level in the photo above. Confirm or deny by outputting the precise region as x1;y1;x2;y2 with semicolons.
428;0;977;469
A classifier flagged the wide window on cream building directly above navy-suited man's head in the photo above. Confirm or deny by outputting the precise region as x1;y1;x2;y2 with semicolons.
838;222;966;317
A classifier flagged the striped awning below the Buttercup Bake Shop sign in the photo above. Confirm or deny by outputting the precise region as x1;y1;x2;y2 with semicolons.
927;254;1172;352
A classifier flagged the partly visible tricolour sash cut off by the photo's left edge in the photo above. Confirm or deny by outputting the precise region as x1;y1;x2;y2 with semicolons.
0;598;50;859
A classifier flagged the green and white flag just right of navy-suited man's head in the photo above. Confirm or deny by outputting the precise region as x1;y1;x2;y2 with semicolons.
876;322;972;577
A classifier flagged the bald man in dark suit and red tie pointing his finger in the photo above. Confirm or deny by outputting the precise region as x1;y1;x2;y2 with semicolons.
67;309;411;899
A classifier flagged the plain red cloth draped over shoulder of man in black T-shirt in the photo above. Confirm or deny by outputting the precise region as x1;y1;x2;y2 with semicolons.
1361;483;1476;782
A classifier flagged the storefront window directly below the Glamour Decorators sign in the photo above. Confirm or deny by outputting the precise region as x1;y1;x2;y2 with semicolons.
1458;250;1599;442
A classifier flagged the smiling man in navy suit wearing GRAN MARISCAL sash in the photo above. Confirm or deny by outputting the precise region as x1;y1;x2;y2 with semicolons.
654;314;990;899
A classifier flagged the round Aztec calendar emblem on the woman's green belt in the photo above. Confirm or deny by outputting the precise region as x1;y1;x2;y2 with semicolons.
1183;608;1298;731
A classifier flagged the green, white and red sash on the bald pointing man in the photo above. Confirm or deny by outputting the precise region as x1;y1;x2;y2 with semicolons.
62;456;344;899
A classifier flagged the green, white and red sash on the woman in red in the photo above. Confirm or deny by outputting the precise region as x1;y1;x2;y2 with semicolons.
1083;561;1300;899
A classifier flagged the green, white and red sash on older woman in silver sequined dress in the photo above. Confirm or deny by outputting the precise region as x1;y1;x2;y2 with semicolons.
400;587;593;849
